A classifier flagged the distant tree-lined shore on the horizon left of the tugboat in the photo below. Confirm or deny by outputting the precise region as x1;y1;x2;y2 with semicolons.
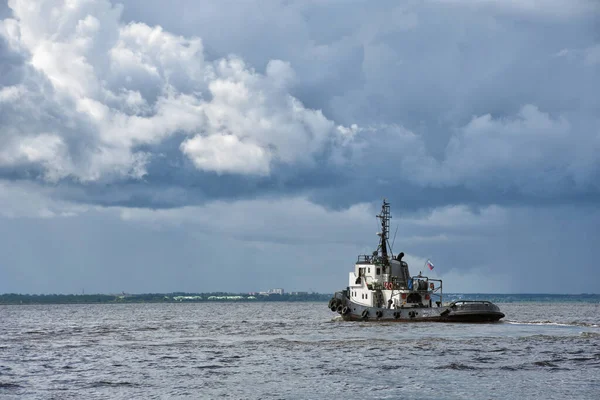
0;292;332;304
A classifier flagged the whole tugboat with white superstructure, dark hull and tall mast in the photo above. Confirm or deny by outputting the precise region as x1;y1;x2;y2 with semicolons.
329;199;504;322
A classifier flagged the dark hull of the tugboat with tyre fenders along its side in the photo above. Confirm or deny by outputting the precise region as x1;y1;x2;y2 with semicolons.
330;297;504;322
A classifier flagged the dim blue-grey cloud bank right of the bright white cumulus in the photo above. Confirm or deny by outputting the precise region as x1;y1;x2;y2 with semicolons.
348;104;600;196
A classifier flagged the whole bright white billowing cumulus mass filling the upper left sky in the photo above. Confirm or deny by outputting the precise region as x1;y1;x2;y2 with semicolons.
0;0;352;181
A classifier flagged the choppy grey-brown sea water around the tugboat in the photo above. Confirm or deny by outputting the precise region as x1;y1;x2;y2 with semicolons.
0;295;600;400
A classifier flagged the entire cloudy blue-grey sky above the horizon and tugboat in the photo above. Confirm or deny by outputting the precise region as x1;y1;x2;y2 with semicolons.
0;0;600;293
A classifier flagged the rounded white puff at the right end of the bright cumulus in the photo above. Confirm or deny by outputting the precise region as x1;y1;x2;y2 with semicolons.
182;58;336;175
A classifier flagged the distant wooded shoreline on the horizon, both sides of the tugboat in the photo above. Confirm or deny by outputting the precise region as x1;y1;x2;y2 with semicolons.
0;292;600;305
